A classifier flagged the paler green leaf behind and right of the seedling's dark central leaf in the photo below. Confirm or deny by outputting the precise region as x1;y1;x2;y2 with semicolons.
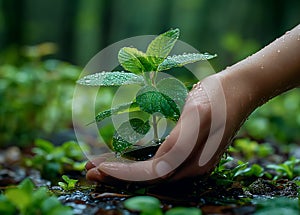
156;78;188;112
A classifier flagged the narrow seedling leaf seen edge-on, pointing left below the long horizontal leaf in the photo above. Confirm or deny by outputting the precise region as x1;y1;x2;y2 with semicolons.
95;102;140;122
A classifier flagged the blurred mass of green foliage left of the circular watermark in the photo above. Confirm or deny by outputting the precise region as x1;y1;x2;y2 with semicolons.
0;55;80;146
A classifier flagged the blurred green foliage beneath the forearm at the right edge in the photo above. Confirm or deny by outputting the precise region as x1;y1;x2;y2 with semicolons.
241;88;300;143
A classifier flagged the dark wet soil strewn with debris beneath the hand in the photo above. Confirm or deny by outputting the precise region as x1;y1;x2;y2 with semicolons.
0;146;299;215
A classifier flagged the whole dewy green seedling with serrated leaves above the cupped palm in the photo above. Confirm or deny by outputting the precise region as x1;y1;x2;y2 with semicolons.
77;29;216;156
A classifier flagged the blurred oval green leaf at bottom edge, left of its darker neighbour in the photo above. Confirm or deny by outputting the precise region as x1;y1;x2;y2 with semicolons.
124;196;162;215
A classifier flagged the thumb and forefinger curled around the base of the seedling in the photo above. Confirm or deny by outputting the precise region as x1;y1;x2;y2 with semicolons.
97;101;205;182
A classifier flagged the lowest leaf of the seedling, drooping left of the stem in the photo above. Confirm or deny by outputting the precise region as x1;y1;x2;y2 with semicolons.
112;118;150;152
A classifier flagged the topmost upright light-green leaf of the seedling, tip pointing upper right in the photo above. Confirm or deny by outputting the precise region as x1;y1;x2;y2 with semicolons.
146;28;180;70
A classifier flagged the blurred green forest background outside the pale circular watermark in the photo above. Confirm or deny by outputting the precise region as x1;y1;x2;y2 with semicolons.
0;0;300;146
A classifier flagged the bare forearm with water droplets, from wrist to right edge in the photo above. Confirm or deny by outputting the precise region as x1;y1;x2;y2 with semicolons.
219;25;300;111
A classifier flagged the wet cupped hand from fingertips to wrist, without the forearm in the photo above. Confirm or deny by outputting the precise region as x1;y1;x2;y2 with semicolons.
86;75;249;183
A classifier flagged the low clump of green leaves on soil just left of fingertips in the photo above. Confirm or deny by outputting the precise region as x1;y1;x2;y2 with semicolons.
25;139;88;179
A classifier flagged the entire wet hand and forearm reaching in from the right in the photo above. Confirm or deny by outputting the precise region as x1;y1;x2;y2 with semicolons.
86;25;300;184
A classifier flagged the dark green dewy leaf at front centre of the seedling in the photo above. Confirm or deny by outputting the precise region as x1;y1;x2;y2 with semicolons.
136;86;180;121
